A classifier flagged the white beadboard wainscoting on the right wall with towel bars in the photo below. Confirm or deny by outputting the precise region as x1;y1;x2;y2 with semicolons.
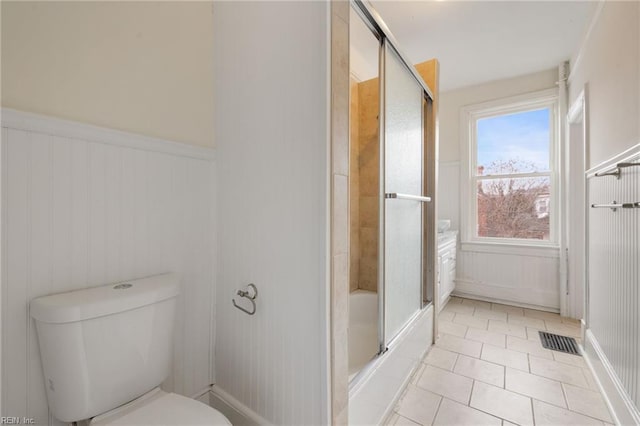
585;144;640;424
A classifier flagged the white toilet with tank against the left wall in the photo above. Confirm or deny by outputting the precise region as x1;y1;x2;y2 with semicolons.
30;273;231;426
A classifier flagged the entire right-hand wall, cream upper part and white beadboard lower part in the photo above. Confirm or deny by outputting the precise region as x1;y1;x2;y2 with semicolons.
569;1;640;424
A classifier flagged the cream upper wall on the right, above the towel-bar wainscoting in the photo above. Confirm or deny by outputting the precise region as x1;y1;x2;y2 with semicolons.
569;1;640;168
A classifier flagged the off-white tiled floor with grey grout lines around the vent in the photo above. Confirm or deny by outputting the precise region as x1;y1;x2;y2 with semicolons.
387;298;613;426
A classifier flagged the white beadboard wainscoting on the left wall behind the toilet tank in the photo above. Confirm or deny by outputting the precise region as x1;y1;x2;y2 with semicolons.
1;109;215;424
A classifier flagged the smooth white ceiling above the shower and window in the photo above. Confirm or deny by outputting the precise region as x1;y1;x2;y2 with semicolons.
351;0;596;91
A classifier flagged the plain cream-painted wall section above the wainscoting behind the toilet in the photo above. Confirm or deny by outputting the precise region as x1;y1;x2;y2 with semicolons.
1;1;213;147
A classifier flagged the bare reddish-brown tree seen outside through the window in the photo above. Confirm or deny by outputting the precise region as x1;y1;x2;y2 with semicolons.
477;159;549;239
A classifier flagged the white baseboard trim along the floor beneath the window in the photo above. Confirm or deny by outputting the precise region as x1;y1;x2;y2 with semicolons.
451;278;560;314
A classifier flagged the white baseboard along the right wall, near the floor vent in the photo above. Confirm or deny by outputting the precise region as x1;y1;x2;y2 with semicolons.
583;329;640;425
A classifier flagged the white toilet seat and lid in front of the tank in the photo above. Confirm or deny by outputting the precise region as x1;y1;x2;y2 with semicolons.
89;388;231;426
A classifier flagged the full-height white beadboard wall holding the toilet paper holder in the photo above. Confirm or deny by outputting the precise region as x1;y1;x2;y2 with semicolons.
214;2;330;425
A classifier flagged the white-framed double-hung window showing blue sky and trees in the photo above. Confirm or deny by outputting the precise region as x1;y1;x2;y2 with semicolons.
462;90;558;245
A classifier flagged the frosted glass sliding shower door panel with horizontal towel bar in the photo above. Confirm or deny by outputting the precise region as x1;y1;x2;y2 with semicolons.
380;40;427;350
